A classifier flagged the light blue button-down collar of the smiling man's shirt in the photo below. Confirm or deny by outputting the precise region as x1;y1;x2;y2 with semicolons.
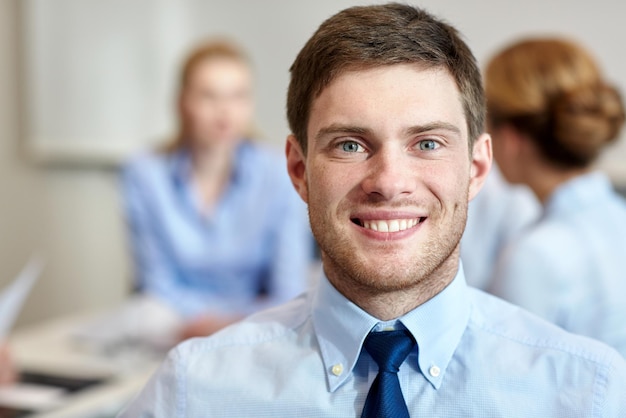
312;263;470;392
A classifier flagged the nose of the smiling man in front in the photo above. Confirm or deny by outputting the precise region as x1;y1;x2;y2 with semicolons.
361;149;417;200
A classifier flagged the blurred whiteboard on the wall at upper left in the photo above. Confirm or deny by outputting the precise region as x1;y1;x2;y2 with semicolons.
20;0;187;162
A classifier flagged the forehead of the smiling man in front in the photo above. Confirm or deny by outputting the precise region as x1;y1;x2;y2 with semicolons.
308;64;467;139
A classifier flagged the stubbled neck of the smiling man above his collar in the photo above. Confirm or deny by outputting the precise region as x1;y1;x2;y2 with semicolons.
322;251;459;321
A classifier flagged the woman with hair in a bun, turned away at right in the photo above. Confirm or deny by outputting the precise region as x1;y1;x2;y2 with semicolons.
485;39;626;355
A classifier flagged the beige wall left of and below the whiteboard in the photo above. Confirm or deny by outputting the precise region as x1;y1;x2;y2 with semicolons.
0;0;129;325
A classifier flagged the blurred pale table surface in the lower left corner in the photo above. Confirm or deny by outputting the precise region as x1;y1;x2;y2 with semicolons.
9;304;171;418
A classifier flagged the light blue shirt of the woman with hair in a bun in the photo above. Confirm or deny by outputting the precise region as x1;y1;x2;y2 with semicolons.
491;172;626;356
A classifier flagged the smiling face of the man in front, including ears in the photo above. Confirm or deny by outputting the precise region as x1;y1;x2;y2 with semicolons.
287;64;491;292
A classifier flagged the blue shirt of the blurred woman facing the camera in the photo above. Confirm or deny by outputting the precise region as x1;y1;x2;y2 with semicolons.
122;142;314;316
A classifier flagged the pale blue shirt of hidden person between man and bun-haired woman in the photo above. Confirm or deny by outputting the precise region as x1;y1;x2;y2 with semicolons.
461;164;541;290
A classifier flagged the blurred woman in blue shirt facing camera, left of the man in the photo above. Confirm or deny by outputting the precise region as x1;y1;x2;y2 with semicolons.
123;40;313;338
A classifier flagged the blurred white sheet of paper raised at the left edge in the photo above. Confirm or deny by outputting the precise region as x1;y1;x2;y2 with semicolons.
0;256;43;339
